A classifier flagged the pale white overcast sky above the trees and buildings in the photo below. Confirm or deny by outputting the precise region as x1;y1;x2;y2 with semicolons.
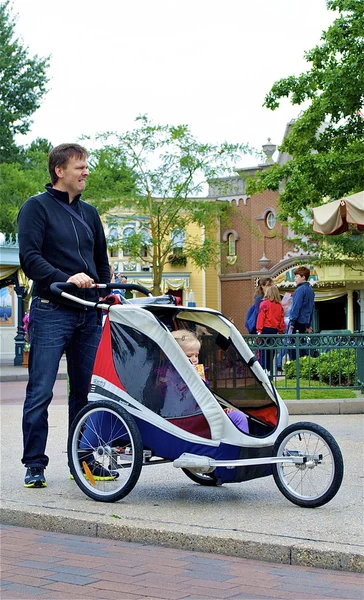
13;0;335;164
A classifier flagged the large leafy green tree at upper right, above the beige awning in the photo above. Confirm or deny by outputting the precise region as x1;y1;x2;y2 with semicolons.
248;0;364;263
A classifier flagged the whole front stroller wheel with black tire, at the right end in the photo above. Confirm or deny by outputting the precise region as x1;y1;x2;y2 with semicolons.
273;422;344;508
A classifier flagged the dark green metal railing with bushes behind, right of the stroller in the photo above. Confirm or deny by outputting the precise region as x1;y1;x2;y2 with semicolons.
243;331;364;399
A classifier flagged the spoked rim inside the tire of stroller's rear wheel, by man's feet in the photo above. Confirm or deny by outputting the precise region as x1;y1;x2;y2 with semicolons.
72;408;139;498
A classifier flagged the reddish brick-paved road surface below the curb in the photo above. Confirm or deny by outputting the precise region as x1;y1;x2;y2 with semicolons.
0;525;364;600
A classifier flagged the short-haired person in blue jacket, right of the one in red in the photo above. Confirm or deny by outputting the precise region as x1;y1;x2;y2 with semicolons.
288;267;315;360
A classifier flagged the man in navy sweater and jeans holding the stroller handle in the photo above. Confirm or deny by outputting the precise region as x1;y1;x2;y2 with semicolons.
18;144;116;488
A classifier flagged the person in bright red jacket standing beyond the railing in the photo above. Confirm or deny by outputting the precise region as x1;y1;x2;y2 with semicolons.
257;285;285;375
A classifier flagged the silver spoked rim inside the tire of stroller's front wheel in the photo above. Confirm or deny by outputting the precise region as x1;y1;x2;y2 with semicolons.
277;429;335;501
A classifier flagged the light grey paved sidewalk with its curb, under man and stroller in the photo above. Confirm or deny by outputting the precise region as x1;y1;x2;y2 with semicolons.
0;363;364;572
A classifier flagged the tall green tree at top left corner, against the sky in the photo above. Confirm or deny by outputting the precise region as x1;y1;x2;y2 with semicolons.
0;0;49;163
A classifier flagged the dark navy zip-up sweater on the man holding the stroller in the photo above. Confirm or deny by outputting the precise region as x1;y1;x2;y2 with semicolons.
18;185;110;308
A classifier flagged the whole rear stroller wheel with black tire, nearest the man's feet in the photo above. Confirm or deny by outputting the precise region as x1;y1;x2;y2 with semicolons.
68;400;143;502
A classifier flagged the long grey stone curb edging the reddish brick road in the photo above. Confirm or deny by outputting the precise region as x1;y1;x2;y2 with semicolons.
0;508;364;573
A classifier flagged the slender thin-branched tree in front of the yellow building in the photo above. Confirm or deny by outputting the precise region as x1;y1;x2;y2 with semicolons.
87;115;253;294
